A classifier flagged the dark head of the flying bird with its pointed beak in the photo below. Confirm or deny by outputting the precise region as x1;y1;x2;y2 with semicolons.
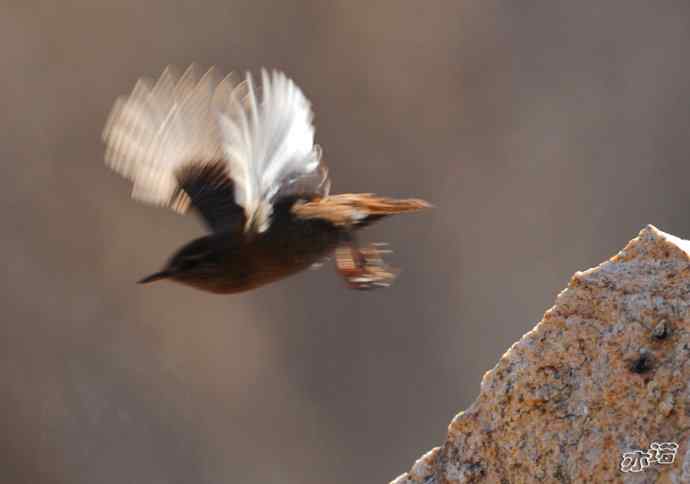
137;236;222;284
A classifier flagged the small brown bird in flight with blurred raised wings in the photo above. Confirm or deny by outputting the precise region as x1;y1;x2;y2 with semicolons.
103;64;431;294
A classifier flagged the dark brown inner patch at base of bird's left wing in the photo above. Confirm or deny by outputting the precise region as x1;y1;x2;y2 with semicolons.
176;160;246;232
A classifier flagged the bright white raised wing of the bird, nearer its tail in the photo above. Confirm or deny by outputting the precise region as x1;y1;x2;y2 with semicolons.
220;70;327;232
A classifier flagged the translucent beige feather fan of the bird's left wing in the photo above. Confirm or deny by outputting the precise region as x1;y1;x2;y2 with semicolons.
103;66;226;212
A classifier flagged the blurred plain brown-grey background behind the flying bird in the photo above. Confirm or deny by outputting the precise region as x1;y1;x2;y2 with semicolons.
0;0;690;484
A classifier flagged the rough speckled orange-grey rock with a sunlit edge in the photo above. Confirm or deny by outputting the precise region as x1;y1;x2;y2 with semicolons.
393;226;690;484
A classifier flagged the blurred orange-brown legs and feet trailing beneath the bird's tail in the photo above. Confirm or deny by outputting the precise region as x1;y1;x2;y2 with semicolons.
335;233;397;289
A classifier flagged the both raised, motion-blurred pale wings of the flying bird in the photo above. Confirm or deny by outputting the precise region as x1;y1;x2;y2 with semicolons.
103;66;328;232
